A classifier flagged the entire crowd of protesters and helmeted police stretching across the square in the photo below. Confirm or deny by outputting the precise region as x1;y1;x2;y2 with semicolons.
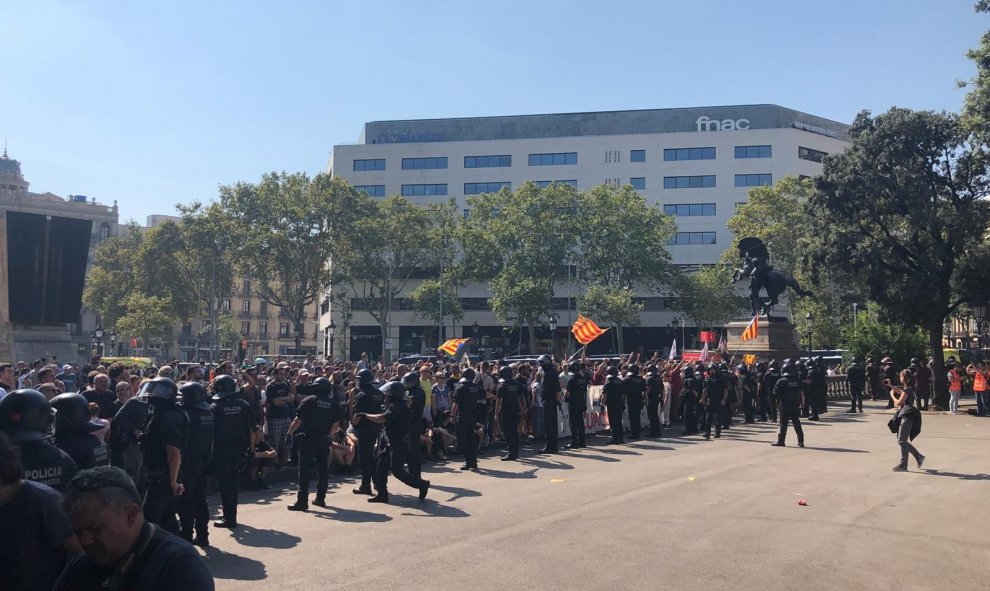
0;354;990;589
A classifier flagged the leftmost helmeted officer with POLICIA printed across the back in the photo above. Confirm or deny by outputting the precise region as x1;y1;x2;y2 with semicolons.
0;389;76;491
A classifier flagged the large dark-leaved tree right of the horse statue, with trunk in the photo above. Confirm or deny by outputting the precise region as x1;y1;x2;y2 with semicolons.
808;108;990;408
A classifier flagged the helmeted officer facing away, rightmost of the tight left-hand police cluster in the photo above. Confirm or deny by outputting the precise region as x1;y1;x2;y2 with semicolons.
210;375;254;529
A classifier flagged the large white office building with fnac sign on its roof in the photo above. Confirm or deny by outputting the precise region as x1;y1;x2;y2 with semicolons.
322;105;848;358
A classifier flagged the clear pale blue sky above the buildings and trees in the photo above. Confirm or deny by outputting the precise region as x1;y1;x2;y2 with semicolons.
0;0;990;223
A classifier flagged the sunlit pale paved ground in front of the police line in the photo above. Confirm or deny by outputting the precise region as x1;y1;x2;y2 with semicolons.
201;402;990;590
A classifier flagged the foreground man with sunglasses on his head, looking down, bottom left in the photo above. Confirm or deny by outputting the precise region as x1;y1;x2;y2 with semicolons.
53;466;214;591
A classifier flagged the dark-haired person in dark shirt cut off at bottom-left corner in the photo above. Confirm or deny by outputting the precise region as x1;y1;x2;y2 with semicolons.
0;434;80;591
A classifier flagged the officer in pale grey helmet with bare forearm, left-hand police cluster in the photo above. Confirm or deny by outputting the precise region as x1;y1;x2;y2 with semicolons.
138;378;189;535
